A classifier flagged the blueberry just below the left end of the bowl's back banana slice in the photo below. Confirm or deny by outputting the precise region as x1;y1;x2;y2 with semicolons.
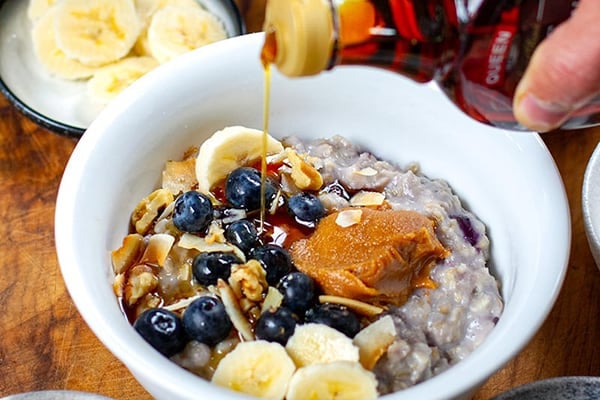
173;190;213;232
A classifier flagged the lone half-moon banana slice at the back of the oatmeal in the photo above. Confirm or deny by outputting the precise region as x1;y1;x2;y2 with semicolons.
196;126;283;193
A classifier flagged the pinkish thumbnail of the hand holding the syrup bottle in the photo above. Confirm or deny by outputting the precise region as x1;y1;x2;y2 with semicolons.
515;93;571;132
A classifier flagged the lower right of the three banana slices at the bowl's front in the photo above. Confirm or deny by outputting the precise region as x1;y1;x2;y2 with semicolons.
286;361;378;400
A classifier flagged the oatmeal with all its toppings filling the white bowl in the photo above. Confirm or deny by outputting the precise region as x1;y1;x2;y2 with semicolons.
112;127;503;400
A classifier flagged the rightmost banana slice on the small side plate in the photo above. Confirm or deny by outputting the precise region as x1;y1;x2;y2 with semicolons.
148;6;227;63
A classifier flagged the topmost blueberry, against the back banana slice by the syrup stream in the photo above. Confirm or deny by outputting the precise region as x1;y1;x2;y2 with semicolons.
225;167;277;210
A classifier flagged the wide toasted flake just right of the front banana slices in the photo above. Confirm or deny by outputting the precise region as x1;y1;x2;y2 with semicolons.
353;315;396;370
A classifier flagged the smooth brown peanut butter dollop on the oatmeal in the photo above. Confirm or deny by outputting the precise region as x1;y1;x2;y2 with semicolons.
290;208;450;304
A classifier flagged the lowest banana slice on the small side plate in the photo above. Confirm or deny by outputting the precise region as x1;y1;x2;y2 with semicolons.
88;57;158;104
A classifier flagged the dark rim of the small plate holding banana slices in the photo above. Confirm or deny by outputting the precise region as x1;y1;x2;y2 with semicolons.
0;0;247;139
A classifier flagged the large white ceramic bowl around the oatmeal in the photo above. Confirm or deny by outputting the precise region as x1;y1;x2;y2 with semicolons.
56;34;570;400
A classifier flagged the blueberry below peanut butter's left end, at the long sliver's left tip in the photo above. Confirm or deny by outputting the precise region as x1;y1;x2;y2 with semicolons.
277;272;317;315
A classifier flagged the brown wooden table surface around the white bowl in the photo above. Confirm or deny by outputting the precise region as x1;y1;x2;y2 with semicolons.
0;3;600;400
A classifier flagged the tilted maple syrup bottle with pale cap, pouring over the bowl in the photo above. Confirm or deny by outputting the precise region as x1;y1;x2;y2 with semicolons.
261;0;600;130
